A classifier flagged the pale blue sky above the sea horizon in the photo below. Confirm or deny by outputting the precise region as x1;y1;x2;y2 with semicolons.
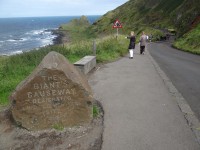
0;0;128;18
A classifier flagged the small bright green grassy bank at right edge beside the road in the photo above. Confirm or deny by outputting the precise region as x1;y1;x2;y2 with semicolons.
173;24;200;55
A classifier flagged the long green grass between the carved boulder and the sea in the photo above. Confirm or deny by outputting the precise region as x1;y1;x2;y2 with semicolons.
0;36;128;105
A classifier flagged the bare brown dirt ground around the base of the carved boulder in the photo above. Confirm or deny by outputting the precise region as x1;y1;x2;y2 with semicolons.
0;100;103;150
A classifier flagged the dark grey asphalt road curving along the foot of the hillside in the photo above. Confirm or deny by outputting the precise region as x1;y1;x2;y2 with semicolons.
148;42;200;120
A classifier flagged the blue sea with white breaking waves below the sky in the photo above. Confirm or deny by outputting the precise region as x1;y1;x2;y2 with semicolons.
0;16;100;56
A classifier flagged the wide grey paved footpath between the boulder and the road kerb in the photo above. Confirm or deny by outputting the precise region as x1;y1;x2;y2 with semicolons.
89;45;200;150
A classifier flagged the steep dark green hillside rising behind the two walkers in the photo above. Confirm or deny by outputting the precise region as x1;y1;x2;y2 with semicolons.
90;0;200;51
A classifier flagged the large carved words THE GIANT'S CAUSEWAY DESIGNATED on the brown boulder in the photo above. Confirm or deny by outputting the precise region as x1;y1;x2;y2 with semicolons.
26;75;76;104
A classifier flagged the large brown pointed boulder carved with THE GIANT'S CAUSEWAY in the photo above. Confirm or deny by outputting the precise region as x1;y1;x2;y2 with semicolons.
10;52;93;131
